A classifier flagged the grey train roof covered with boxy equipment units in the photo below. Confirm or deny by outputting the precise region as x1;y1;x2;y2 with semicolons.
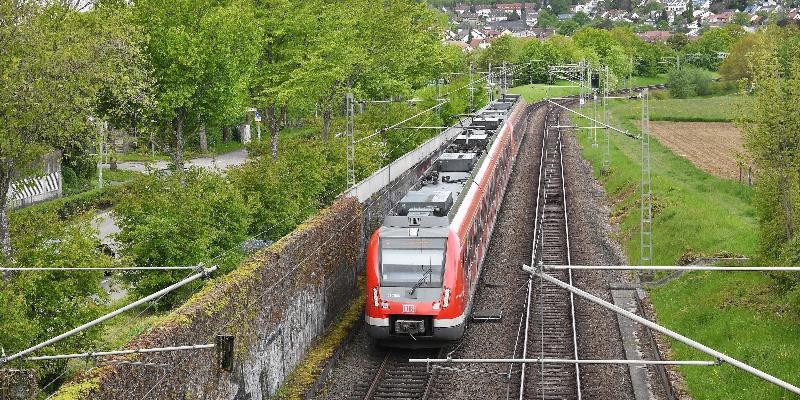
381;95;520;233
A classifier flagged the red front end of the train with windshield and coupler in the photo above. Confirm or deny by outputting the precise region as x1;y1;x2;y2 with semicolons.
364;225;465;346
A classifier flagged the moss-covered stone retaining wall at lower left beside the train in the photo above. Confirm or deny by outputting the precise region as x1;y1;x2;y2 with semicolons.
54;198;363;400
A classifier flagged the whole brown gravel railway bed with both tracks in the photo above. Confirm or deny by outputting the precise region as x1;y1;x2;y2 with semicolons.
311;86;669;400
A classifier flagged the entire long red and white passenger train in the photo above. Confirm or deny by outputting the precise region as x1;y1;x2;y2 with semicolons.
364;96;526;344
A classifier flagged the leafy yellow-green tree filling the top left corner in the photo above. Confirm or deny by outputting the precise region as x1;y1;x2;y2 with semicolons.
0;1;149;257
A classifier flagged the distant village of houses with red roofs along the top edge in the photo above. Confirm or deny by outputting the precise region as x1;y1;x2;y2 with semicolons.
441;0;800;52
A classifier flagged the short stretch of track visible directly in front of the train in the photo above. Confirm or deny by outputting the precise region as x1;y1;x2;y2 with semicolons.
348;349;441;400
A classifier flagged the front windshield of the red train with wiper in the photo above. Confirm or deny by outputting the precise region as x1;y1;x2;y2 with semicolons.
381;238;447;287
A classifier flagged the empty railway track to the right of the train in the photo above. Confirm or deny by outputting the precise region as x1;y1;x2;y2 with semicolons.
519;101;581;400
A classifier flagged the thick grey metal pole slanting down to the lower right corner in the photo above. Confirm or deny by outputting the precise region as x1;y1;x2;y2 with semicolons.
523;265;800;394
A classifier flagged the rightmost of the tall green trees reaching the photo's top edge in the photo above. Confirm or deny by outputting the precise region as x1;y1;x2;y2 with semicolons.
289;0;445;141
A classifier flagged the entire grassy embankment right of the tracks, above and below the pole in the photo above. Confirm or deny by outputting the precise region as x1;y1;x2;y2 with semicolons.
512;87;800;400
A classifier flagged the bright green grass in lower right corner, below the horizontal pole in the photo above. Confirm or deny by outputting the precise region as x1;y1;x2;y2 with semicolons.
650;272;800;400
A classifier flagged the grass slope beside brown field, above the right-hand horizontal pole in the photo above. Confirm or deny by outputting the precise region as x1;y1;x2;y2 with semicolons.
578;99;757;265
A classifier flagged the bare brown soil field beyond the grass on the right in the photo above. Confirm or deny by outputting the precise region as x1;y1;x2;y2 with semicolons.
650;121;747;180
